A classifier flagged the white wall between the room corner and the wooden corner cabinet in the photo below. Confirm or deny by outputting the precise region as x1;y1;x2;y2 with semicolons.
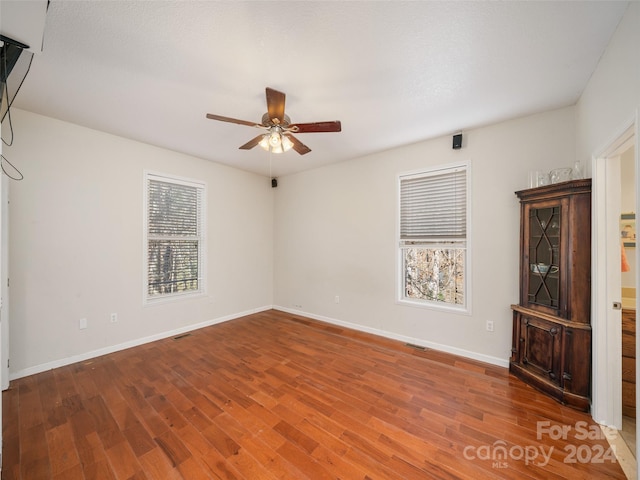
274;107;575;366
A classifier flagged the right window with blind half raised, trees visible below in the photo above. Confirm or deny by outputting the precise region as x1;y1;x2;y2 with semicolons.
399;164;469;311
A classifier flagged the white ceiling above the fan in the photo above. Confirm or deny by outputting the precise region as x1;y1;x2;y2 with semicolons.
0;0;628;176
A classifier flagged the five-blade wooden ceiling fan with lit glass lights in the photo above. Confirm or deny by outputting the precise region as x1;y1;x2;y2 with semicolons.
207;87;342;155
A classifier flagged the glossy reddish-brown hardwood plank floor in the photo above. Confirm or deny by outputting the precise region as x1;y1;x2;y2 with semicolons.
2;311;625;480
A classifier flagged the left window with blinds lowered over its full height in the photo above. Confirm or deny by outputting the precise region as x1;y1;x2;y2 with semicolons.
145;173;205;300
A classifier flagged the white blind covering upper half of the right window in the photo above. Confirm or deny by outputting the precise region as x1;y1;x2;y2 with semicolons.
400;167;467;244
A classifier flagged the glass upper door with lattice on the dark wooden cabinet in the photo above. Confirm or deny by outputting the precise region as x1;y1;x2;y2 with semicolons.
528;205;561;309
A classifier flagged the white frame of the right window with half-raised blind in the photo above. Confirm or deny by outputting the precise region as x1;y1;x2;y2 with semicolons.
396;161;472;315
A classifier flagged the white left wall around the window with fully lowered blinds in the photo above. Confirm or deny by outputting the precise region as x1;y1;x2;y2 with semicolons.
5;109;273;378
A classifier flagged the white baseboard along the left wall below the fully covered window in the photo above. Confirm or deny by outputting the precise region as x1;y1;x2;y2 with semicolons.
11;305;273;380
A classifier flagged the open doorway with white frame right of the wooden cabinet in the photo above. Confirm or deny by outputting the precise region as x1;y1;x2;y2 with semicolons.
591;112;640;478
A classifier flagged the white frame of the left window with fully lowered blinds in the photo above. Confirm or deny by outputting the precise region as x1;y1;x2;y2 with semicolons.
142;170;207;305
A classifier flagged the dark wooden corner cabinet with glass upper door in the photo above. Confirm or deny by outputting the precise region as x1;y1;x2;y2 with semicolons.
509;179;591;411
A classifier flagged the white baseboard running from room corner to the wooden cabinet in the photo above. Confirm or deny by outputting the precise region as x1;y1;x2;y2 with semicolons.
273;305;509;368
